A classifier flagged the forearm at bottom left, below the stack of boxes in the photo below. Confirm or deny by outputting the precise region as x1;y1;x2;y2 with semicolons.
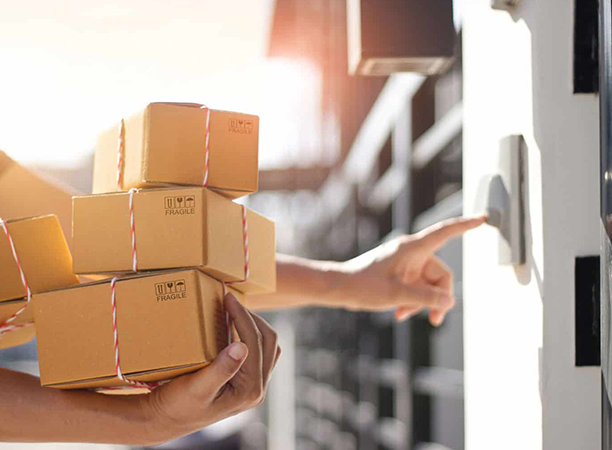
0;369;156;445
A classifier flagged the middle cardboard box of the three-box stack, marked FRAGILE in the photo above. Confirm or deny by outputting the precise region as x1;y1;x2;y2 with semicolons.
72;188;276;294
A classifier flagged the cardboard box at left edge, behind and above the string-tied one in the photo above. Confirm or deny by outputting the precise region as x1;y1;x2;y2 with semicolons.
0;151;79;247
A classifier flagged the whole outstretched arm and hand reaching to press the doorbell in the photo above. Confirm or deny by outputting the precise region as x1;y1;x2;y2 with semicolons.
247;217;486;325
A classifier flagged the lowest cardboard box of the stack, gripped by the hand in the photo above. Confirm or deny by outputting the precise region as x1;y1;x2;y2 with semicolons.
32;269;239;389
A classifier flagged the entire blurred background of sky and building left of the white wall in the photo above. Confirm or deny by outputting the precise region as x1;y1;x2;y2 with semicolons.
0;0;464;450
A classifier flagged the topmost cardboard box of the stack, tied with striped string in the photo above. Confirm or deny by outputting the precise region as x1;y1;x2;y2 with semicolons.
93;103;259;198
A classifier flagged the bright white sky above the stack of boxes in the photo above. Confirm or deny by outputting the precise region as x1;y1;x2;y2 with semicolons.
0;0;326;166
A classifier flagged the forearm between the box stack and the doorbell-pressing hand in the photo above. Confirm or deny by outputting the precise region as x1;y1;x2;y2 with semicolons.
247;254;347;310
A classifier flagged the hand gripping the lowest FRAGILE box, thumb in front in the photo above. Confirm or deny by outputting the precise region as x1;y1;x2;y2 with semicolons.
142;294;281;442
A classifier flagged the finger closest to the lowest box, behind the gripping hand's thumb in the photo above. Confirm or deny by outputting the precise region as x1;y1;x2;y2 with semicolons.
224;292;263;390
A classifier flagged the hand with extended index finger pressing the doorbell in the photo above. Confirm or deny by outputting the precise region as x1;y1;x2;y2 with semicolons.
334;216;486;326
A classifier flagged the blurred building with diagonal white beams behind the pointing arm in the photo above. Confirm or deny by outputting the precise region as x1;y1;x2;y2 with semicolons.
249;0;464;450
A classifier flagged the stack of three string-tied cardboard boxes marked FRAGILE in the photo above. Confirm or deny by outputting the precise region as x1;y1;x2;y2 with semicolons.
0;103;276;388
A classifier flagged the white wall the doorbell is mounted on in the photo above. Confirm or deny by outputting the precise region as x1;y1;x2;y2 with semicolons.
463;0;600;450
